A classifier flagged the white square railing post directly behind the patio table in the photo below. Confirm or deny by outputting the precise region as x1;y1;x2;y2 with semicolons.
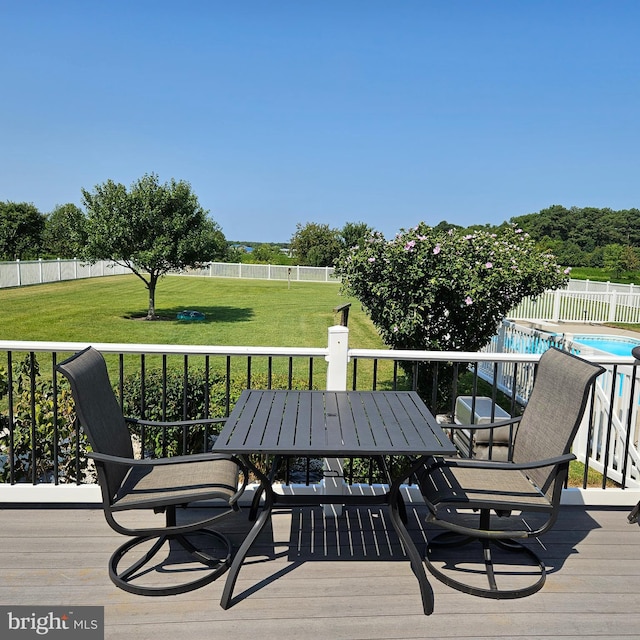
322;326;349;516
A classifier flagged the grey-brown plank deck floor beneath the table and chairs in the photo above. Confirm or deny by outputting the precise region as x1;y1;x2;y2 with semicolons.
0;507;640;640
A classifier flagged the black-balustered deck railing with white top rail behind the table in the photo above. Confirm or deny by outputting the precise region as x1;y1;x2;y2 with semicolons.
0;343;640;489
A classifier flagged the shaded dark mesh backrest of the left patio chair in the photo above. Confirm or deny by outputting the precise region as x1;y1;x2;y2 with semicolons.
57;347;133;495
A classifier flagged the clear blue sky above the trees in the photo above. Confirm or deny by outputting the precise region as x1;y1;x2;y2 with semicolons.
0;0;640;242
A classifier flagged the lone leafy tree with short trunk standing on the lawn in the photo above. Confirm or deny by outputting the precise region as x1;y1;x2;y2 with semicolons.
82;174;226;320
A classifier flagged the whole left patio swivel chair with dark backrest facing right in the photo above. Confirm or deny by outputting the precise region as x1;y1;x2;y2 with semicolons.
57;347;248;595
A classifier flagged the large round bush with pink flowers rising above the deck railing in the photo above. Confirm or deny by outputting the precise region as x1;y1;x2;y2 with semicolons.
336;223;568;351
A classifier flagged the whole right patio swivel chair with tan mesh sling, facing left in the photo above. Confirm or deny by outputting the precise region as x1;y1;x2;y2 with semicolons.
418;348;604;599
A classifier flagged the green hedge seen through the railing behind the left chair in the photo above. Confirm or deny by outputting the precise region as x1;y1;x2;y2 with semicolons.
0;355;316;482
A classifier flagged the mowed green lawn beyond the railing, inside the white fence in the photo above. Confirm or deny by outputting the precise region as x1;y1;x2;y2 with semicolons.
0;275;383;349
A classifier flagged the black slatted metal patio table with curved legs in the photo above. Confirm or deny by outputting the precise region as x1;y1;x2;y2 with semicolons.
214;389;455;615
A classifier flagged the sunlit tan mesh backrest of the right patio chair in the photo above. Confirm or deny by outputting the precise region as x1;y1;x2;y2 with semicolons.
513;348;604;497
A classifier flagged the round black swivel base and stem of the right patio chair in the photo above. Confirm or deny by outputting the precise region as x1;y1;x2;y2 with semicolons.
425;510;546;600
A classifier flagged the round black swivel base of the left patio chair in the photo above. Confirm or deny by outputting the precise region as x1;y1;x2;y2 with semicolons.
109;529;232;596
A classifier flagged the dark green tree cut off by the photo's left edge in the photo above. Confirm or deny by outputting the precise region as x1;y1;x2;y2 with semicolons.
0;201;45;260
